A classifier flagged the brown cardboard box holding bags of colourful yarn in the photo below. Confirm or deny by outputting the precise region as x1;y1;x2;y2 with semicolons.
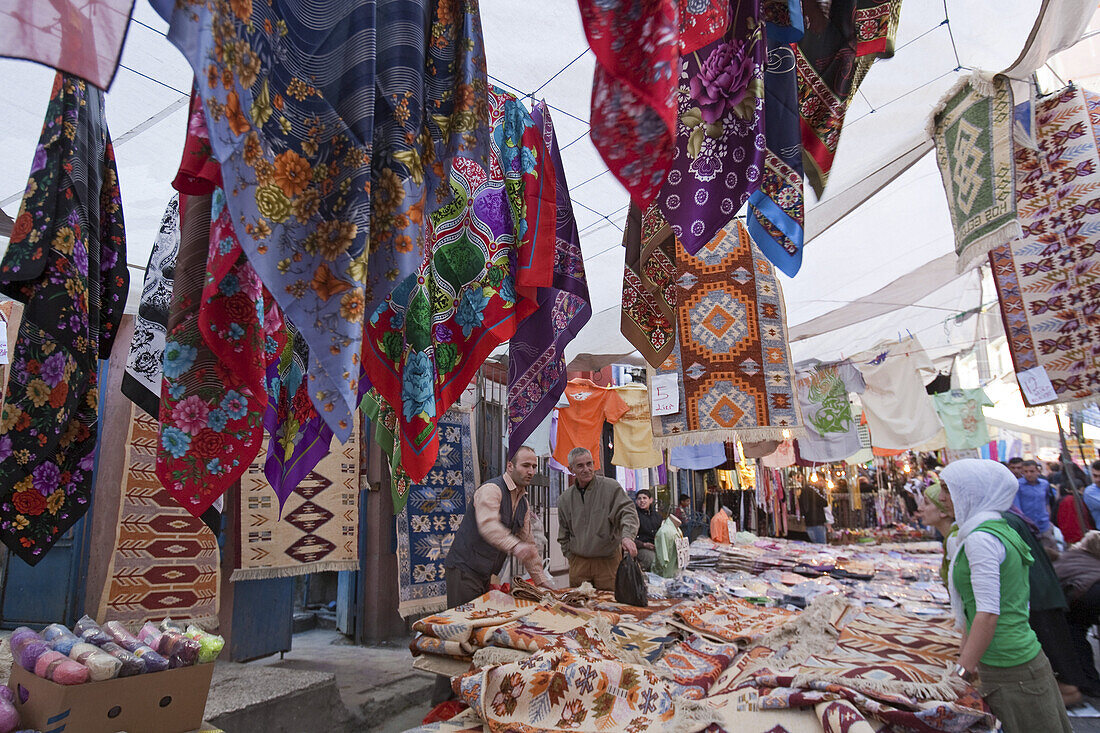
8;664;213;733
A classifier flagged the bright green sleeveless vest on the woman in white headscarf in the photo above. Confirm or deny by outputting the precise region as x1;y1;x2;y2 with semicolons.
955;519;1041;667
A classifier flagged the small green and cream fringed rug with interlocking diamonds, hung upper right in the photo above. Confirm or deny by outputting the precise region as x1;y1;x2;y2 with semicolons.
932;73;1020;272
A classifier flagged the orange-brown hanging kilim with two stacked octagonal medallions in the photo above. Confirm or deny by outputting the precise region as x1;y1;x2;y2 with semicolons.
649;220;801;449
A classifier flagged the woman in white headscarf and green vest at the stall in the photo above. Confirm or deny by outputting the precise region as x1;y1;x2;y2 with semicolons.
941;459;1071;733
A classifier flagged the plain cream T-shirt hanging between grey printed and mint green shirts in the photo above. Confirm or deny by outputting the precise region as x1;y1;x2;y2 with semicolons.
853;336;943;450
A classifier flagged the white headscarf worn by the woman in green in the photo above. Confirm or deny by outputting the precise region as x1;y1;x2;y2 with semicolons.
939;458;1020;628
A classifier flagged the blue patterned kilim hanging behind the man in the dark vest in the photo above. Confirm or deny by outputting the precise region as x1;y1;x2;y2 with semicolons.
395;407;481;617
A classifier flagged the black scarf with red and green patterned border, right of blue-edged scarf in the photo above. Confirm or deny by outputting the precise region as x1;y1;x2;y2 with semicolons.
794;0;901;198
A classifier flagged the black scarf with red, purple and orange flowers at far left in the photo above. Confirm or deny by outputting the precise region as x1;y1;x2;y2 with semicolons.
0;73;130;565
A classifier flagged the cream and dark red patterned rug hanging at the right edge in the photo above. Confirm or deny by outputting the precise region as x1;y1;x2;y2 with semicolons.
989;86;1100;406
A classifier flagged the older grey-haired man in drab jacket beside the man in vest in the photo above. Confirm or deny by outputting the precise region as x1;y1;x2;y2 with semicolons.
558;448;638;590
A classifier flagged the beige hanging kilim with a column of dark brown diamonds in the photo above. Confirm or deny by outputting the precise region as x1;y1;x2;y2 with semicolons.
229;411;360;582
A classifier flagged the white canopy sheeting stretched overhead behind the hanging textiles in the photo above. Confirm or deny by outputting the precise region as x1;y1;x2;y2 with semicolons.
0;0;1100;369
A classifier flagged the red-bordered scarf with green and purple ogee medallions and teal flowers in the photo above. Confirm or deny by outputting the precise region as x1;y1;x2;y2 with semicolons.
363;89;557;481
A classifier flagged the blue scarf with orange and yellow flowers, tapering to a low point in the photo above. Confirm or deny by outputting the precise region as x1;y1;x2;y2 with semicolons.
152;0;381;440
